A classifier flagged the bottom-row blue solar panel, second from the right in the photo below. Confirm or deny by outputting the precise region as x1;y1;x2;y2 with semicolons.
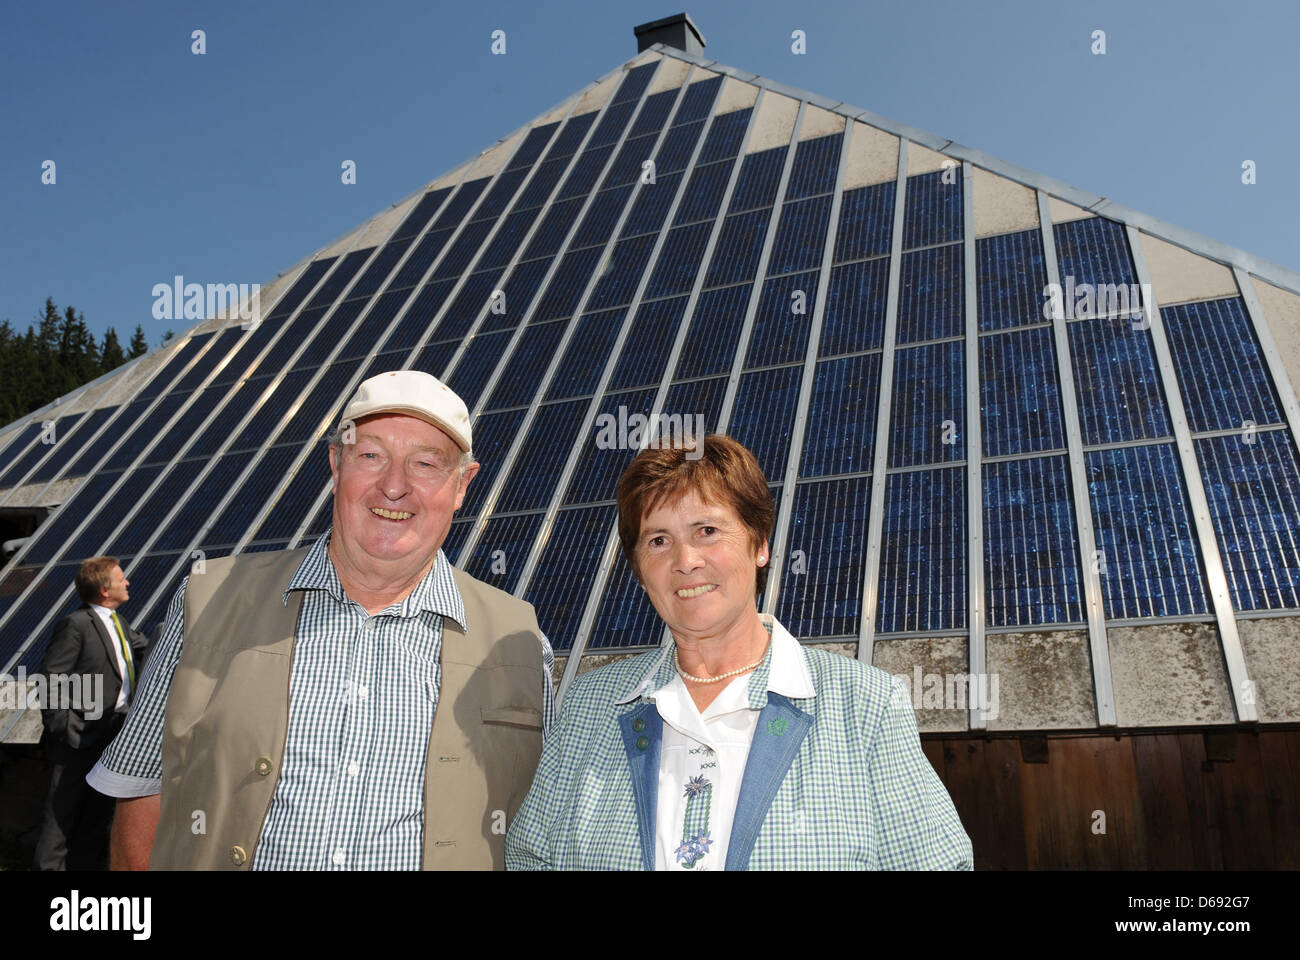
1087;444;1205;619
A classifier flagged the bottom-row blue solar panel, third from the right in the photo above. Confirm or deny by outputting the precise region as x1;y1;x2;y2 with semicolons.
984;457;1086;627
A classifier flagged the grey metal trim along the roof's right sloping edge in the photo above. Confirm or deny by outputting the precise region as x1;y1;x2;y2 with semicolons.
650;43;1300;294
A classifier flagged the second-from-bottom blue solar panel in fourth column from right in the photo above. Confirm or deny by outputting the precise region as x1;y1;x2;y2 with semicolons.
889;341;966;467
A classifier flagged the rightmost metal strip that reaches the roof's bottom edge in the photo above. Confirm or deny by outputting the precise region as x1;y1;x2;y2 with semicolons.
1125;224;1258;723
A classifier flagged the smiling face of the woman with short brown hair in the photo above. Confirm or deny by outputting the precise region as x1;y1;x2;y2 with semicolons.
637;492;767;640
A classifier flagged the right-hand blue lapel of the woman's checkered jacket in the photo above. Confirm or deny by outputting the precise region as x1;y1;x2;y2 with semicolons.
728;693;813;870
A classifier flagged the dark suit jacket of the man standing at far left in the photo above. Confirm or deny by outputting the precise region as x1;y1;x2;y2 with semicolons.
40;605;148;749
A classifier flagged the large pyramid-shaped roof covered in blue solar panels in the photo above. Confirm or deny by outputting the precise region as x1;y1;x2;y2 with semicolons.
0;46;1300;731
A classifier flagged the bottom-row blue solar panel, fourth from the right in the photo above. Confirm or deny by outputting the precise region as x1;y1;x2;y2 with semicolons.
876;467;967;633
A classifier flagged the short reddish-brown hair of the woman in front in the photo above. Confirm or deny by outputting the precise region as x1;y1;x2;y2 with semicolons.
619;433;776;593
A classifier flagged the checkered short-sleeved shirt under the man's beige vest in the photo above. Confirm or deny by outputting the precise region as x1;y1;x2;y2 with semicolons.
86;531;555;870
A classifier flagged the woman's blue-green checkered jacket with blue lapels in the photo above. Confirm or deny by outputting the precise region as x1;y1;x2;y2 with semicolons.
506;623;972;870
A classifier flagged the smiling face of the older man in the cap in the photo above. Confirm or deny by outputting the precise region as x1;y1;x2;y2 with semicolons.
329;414;478;583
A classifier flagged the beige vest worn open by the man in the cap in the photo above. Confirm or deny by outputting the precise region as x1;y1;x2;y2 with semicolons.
150;549;542;870
